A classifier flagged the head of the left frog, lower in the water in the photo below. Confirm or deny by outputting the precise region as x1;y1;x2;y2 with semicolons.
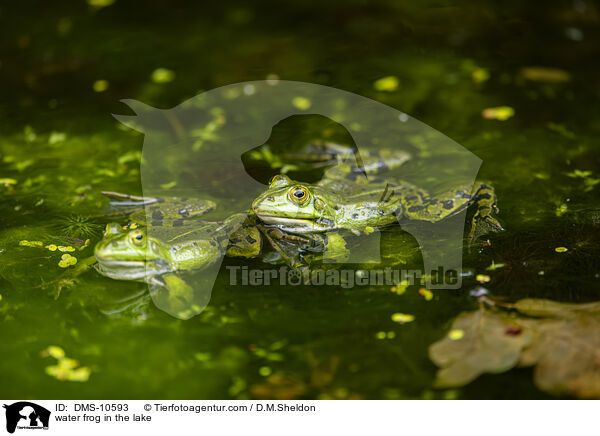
94;224;171;280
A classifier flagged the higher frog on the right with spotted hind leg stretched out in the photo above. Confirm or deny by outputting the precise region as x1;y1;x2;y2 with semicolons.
252;170;503;258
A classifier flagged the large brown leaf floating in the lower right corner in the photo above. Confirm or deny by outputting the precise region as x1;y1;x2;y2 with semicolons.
429;299;600;398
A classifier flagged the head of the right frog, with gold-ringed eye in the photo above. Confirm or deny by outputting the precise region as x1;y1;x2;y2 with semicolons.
252;175;339;233
